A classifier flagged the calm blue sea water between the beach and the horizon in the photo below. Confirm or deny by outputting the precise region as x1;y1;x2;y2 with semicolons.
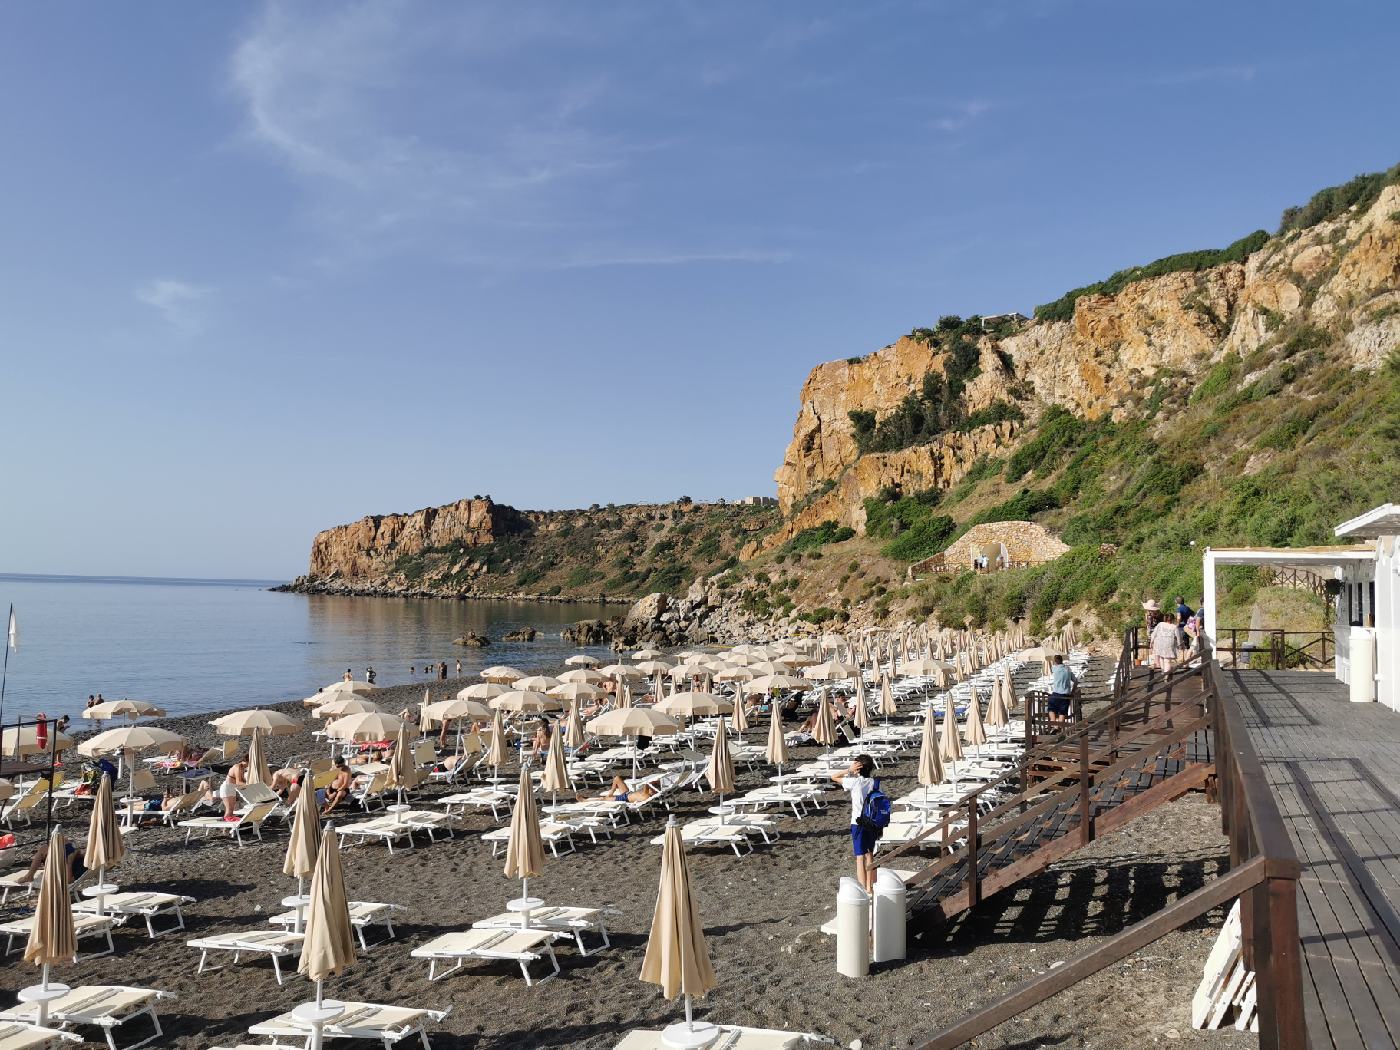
0;574;616;718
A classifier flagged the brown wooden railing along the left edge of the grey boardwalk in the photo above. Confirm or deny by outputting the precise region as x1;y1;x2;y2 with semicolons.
917;661;1308;1050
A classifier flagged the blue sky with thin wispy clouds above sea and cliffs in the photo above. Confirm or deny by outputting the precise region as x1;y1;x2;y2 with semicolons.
0;0;1400;577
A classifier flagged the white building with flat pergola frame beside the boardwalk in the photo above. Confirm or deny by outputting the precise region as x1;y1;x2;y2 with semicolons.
1204;503;1400;711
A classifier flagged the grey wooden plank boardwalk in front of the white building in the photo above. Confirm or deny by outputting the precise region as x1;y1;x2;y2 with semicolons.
1222;671;1400;1050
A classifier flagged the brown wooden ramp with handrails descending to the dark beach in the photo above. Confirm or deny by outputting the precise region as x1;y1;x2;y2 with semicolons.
878;660;1215;918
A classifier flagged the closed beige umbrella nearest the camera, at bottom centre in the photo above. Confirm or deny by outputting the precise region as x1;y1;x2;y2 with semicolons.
640;816;715;1046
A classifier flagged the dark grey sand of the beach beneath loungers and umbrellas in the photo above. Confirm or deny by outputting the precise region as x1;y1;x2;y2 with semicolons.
0;682;1257;1050
